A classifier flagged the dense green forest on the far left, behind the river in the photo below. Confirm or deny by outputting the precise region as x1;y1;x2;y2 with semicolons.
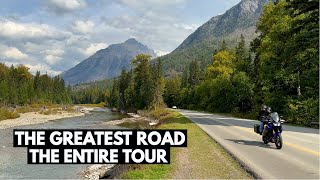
0;63;71;106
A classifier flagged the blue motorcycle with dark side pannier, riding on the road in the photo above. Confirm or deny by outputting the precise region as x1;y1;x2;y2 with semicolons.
254;112;285;149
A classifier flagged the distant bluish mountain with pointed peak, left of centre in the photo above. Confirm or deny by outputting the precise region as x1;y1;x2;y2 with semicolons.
61;38;157;85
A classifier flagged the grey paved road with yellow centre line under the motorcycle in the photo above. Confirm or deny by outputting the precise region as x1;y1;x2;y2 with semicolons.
177;110;320;179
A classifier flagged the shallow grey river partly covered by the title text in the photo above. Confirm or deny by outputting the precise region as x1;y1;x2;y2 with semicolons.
0;108;122;179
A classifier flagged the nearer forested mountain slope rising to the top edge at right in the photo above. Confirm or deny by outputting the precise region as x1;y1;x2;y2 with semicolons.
161;0;270;73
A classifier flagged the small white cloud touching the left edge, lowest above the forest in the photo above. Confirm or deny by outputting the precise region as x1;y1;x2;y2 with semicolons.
0;45;29;60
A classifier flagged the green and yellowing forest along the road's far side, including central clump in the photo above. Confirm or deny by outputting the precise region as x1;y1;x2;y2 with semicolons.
110;0;319;125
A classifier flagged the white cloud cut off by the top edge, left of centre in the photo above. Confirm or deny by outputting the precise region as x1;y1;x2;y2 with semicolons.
47;0;87;14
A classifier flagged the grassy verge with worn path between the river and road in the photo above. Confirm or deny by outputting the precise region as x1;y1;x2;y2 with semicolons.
120;110;253;179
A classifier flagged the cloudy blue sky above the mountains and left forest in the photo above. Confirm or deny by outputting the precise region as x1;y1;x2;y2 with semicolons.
0;0;240;75
